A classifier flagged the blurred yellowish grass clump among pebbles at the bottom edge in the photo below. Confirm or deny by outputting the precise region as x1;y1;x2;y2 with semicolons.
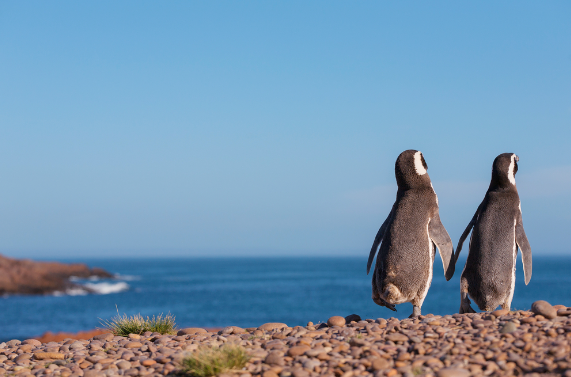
182;344;250;377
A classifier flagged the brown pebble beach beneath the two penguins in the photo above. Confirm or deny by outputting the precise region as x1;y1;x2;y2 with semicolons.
0;301;571;377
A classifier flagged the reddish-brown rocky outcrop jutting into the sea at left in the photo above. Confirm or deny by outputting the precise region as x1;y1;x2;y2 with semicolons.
0;255;112;295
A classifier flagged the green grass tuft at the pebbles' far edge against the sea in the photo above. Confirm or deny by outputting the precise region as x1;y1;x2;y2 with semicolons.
101;312;177;336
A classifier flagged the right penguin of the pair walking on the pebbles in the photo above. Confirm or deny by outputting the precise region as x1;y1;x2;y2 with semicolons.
455;153;531;313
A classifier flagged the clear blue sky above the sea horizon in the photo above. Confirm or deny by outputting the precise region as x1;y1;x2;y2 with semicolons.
0;0;571;258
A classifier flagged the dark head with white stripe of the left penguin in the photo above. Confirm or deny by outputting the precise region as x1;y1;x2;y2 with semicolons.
395;149;430;189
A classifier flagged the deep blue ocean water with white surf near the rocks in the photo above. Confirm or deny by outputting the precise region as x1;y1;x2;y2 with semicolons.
0;255;571;341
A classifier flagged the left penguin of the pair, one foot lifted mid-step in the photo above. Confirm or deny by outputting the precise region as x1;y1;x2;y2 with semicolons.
367;150;454;317
